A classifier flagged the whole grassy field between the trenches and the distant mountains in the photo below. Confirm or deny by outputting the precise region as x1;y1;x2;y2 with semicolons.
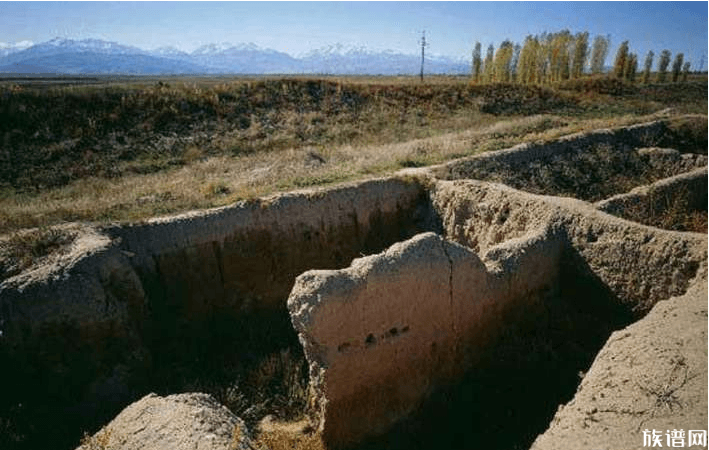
0;76;707;234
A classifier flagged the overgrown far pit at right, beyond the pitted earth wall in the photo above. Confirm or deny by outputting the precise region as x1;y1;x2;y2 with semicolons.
435;122;707;202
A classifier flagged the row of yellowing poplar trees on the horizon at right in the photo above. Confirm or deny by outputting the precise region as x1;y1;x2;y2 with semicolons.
472;30;690;84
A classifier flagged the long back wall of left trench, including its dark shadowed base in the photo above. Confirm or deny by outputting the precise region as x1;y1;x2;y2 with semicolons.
105;180;436;365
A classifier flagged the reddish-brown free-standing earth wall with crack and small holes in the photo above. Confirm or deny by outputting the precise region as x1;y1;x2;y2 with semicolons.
288;230;562;448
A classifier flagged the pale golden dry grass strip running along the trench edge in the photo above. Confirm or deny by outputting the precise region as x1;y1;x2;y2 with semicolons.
0;111;676;233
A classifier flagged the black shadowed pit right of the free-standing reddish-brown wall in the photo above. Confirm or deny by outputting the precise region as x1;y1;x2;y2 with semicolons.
330;246;633;450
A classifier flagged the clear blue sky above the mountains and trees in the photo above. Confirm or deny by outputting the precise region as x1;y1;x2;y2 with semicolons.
0;1;709;68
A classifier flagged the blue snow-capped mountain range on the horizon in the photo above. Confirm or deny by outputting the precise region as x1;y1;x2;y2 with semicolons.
0;38;470;75
